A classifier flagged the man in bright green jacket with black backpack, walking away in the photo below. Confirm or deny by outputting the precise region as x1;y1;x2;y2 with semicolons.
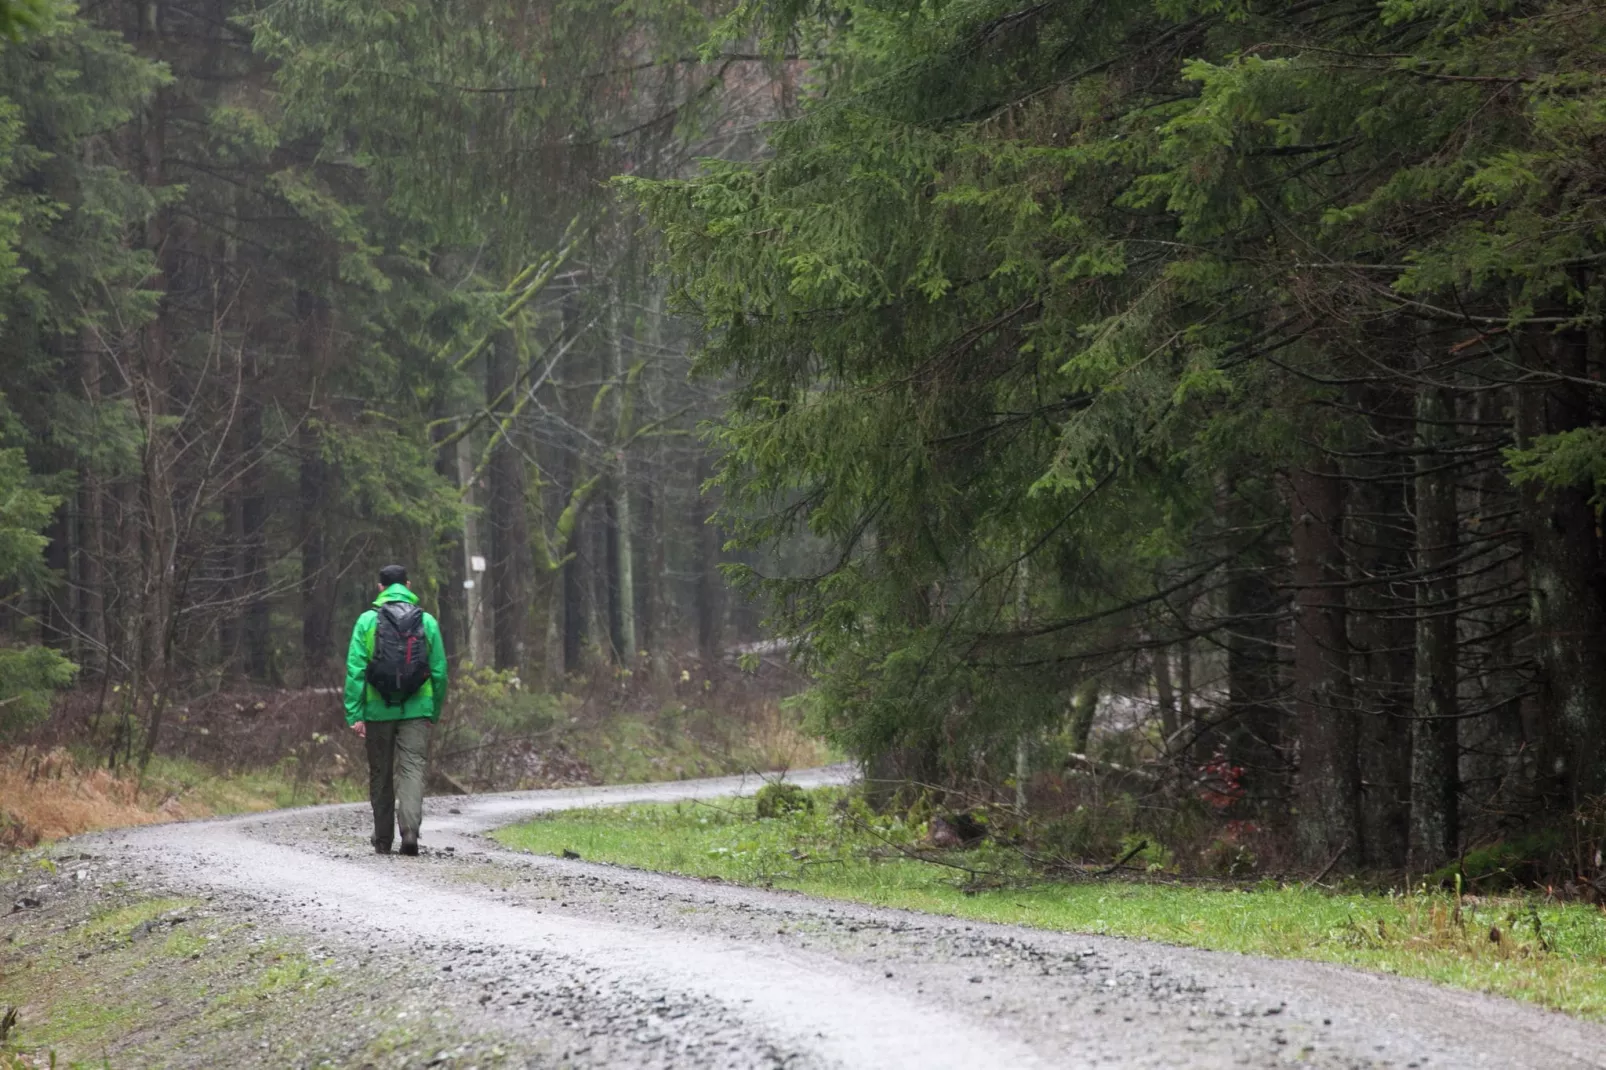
345;566;446;855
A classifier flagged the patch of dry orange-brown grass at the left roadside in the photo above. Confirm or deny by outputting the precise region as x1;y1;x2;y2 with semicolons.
0;747;209;847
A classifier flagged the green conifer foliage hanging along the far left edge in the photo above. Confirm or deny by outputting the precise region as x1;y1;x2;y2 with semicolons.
0;3;164;736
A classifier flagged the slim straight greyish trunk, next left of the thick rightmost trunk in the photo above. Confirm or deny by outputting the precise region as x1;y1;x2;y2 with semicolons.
1407;374;1461;872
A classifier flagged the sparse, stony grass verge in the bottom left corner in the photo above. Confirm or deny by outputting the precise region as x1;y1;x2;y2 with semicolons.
0;853;507;1070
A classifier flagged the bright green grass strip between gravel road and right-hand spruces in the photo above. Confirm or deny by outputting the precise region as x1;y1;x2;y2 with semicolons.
496;789;1606;1020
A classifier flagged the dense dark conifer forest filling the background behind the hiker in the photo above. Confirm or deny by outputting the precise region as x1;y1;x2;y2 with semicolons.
0;0;1606;880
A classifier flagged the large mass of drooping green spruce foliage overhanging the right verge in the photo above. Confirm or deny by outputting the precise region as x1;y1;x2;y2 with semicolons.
622;0;1606;774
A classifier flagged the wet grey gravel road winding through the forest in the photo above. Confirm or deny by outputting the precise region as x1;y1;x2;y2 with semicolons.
80;770;1606;1070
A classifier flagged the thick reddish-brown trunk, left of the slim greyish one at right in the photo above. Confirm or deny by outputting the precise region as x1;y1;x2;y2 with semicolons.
1290;458;1363;863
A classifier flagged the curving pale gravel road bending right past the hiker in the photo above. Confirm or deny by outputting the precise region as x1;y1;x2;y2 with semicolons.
97;770;1606;1070
